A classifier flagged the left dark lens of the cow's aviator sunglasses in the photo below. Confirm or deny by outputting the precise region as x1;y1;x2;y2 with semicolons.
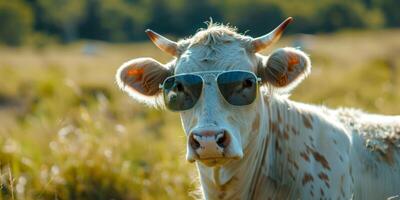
163;74;203;111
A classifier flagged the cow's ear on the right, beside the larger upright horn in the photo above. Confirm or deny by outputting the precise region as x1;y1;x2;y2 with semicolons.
258;47;311;90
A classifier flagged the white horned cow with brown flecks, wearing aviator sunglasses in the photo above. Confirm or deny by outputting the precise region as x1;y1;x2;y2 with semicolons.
116;18;400;200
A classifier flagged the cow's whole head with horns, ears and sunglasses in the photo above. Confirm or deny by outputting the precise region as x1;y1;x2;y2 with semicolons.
116;18;310;166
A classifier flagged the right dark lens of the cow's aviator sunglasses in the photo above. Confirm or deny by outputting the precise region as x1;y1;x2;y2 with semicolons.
217;71;257;106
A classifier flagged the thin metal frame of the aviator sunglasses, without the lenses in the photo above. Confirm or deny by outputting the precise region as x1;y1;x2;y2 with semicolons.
158;70;262;112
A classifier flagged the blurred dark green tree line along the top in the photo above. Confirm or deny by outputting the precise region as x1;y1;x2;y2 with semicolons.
0;0;400;46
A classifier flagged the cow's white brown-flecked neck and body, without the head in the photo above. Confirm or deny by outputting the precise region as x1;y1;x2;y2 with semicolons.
198;96;400;200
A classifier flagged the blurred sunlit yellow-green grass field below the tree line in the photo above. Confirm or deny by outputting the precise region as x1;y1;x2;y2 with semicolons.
0;30;400;200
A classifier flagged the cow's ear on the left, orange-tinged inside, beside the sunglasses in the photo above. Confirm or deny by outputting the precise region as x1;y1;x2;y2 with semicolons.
116;58;173;106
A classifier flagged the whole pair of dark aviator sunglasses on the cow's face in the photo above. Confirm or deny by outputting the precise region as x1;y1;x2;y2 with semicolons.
160;70;261;111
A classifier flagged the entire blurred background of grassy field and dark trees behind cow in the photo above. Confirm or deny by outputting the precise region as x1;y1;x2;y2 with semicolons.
0;0;400;200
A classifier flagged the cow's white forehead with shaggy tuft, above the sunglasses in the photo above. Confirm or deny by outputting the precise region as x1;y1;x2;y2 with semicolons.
175;23;253;74
